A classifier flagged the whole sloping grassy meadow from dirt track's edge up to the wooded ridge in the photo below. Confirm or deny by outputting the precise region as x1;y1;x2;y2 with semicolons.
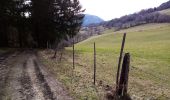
40;23;170;100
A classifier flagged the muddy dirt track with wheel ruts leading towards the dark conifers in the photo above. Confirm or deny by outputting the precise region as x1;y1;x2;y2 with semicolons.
0;51;73;100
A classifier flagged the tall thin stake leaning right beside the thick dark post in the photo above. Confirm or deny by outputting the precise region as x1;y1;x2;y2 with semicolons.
116;33;126;90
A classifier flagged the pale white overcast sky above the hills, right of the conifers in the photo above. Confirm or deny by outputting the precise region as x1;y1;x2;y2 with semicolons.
80;0;169;21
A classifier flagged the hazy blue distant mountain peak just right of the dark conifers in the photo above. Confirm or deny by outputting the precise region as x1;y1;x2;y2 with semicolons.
83;14;104;26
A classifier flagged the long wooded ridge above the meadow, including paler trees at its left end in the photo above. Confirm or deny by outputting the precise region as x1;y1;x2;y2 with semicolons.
75;1;170;42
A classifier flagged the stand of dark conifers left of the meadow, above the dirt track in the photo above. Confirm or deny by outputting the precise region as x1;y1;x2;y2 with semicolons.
0;0;84;48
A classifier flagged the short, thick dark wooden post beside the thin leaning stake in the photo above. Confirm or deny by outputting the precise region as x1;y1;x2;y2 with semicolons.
117;53;130;97
